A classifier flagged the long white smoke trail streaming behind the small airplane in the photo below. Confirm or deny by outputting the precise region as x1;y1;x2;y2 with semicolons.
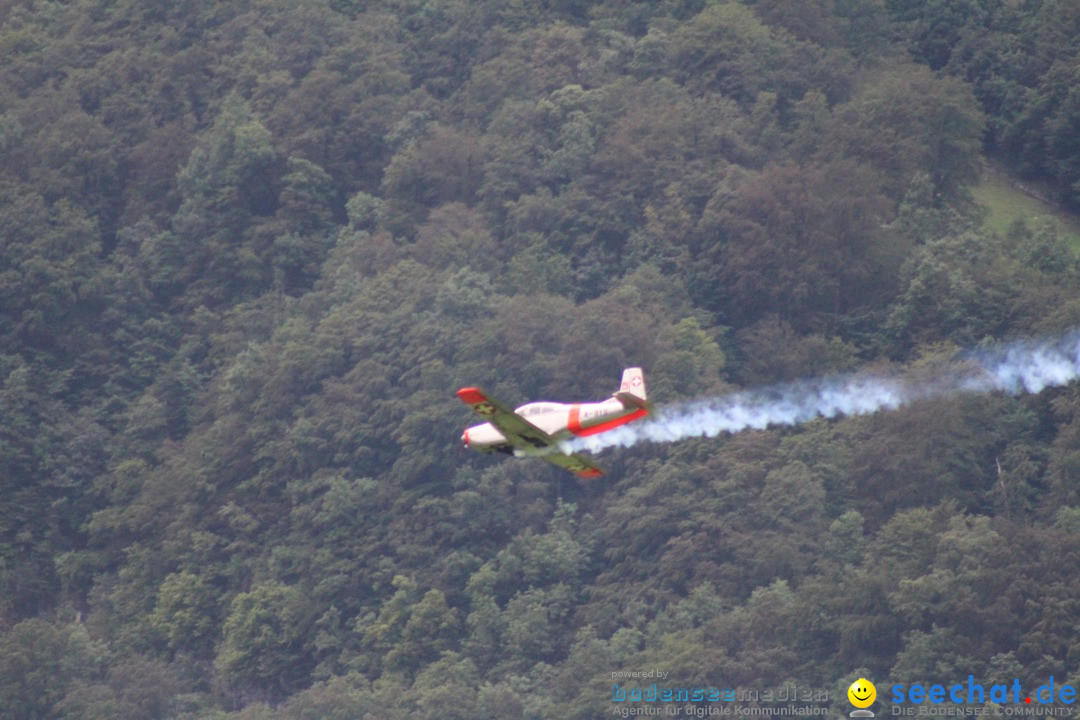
559;330;1080;452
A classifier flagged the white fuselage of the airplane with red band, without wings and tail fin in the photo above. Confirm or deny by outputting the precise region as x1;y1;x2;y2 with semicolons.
462;397;645;454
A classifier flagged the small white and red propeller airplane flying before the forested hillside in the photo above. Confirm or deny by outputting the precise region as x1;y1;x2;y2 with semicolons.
457;367;652;477
